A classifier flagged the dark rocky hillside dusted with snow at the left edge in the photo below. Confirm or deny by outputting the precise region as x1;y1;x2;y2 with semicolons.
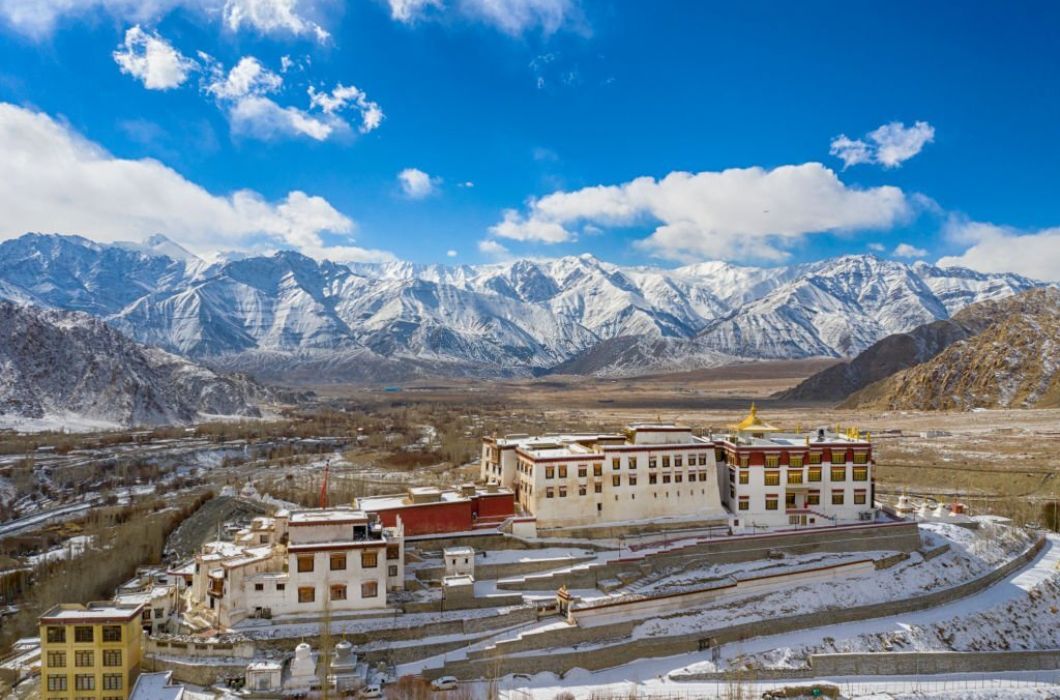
0;301;264;430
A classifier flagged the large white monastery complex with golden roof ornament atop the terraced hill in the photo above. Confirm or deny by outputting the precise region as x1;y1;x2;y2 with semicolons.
480;406;876;531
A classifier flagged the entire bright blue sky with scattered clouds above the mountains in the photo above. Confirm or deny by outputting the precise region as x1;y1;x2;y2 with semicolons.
0;0;1060;279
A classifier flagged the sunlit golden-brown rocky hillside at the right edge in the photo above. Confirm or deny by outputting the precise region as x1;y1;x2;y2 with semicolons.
841;287;1060;409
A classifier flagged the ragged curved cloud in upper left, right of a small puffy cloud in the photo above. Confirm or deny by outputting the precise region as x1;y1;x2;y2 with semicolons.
199;53;383;141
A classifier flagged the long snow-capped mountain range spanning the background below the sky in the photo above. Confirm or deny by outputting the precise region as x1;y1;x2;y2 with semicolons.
0;234;1038;379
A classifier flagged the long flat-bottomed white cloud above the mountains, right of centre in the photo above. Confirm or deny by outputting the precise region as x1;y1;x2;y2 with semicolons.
490;162;914;260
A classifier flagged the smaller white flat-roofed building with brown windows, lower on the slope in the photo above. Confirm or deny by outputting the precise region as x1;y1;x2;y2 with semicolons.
190;508;405;627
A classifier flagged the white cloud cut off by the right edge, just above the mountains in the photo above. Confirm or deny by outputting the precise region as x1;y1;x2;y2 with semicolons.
937;217;1060;282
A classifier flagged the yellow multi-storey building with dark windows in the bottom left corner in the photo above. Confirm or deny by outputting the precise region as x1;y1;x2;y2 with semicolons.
39;602;143;700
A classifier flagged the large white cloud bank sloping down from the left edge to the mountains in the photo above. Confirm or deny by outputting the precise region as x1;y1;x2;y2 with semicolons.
0;103;388;264
